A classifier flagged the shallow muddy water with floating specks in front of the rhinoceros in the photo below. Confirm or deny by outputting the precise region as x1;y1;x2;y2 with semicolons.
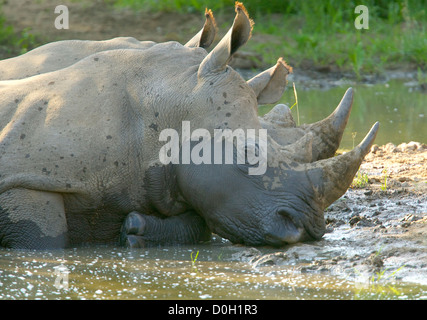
0;241;427;300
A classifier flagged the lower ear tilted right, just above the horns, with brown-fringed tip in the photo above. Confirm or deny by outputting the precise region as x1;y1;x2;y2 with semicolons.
248;58;292;104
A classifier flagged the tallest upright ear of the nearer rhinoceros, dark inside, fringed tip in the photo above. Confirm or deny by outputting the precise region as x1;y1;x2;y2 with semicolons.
198;2;253;77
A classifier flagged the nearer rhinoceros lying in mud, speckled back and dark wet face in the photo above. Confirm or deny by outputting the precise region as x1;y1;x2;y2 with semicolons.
0;3;378;248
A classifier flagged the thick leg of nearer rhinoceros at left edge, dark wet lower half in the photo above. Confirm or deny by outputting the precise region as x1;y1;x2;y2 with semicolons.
0;188;67;249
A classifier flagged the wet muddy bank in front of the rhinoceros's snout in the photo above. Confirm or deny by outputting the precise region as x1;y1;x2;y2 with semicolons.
229;142;427;285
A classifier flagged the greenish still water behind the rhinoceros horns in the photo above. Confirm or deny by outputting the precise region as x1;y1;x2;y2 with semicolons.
260;79;427;149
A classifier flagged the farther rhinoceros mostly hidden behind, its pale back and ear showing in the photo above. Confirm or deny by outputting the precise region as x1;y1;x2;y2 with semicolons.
0;9;217;80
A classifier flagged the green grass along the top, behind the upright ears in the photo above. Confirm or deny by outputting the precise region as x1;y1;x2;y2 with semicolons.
111;0;427;78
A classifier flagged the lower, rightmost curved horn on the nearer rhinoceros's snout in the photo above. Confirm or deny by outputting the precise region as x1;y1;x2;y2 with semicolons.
307;122;379;208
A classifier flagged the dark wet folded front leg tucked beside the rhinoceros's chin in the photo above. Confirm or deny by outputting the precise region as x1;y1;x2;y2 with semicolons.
120;211;212;248
